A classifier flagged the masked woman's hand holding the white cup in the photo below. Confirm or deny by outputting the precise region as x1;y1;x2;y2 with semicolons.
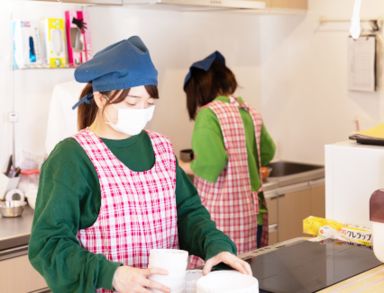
112;266;170;293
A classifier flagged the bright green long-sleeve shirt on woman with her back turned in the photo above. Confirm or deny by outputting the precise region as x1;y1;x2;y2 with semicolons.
191;96;276;224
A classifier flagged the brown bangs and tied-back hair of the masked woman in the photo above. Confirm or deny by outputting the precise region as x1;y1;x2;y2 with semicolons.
77;83;159;130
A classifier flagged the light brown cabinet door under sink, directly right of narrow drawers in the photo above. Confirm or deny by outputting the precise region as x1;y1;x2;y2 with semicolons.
278;183;312;241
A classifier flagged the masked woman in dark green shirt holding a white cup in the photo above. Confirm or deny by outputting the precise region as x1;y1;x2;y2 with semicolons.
29;36;251;293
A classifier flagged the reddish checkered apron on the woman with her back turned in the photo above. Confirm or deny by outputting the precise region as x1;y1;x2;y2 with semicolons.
190;97;268;267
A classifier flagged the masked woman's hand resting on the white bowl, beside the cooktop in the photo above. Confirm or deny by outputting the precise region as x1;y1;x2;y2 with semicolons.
203;251;252;276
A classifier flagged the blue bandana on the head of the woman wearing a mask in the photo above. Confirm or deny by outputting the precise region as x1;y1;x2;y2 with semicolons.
74;36;157;108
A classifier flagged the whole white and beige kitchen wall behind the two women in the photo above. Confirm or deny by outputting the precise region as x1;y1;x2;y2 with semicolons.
0;0;384;167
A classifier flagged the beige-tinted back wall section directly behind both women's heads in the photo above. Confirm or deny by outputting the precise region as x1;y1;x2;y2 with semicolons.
86;6;260;152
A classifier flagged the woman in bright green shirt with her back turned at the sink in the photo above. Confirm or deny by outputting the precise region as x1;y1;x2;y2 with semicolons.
182;51;275;263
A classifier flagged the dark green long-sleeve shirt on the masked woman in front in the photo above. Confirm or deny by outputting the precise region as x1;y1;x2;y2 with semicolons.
29;132;236;293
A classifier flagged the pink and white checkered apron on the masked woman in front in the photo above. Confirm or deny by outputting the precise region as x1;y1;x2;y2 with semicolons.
75;129;178;292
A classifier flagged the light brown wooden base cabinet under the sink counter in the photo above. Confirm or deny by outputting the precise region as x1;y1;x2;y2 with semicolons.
266;179;325;244
